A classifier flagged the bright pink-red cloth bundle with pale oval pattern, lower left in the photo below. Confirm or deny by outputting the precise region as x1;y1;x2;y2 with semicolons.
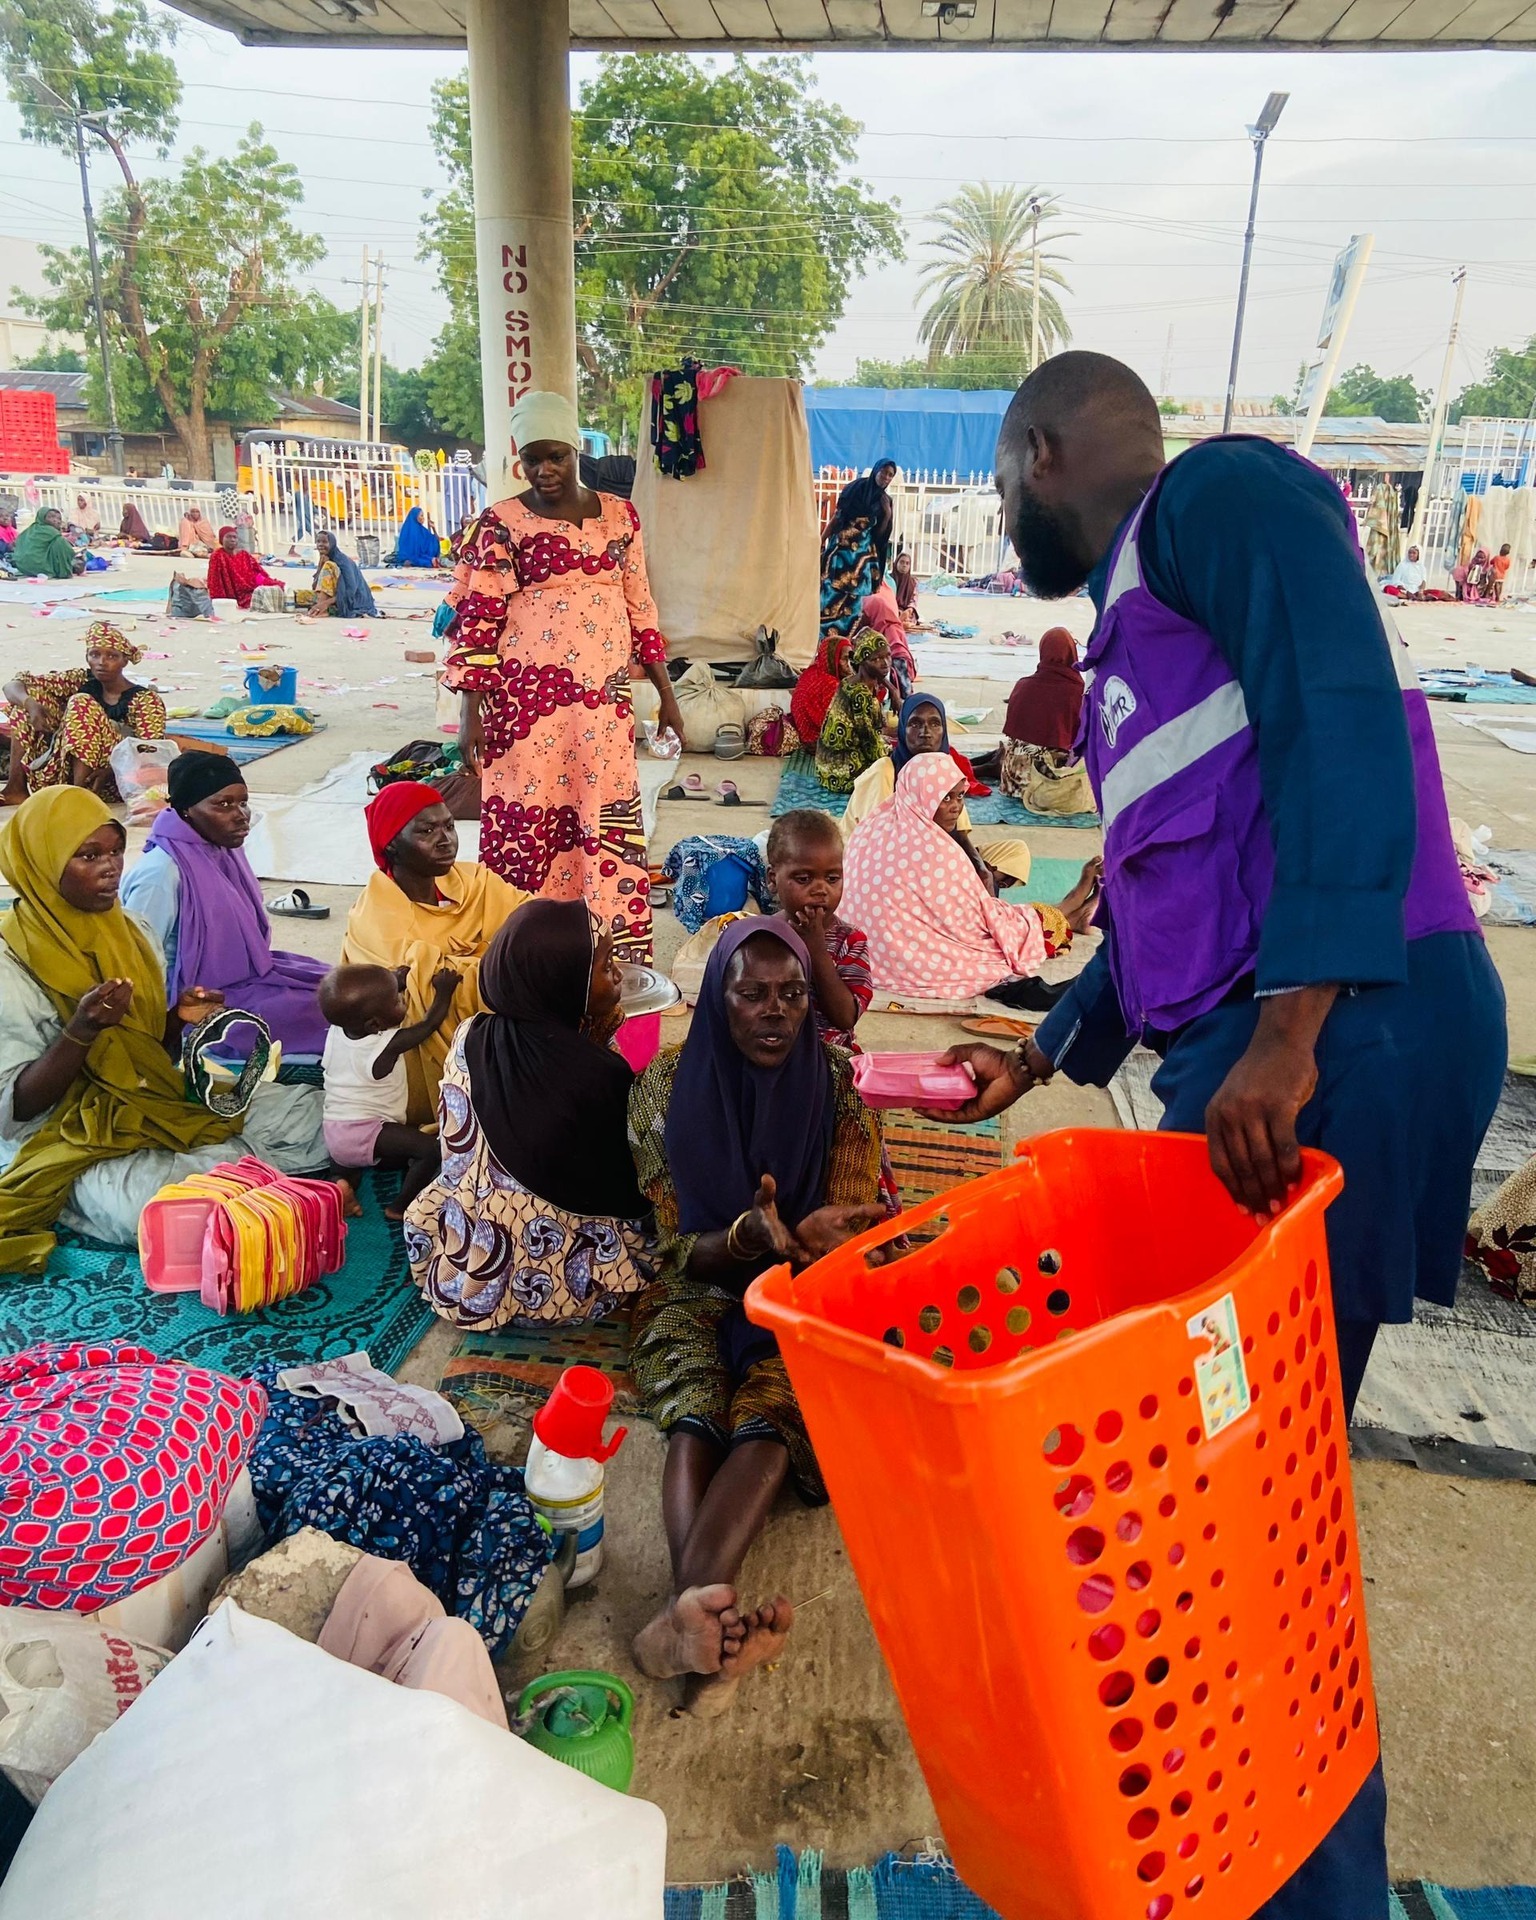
0;1344;267;1613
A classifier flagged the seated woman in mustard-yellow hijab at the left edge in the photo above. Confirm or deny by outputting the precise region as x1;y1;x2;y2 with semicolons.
0;787;326;1273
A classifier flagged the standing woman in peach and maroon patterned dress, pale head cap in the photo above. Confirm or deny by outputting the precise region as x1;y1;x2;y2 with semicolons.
445;394;684;962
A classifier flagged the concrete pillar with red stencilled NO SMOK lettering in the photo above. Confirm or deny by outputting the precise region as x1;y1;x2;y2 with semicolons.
465;0;576;499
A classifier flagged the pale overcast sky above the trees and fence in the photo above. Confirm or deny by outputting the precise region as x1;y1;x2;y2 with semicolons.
0;9;1536;407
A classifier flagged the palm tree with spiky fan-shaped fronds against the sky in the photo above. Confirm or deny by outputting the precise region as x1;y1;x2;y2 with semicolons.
918;180;1075;365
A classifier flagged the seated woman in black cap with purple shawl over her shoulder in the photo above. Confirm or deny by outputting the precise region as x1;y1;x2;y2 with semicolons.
121;753;326;1056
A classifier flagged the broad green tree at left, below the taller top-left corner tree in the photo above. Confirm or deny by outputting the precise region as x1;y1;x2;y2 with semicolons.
15;125;355;474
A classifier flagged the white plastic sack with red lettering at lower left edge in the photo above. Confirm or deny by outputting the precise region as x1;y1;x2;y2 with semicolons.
0;1607;171;1807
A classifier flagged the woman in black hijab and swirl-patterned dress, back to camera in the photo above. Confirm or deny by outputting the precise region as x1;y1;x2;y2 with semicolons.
405;900;651;1332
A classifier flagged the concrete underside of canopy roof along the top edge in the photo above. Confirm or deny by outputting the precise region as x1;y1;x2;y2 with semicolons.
162;0;1536;52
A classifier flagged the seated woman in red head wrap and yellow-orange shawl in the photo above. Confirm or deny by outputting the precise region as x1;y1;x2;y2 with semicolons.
342;780;528;1127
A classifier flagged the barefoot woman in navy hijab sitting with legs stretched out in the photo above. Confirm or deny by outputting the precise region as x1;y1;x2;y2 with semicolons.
630;920;883;1713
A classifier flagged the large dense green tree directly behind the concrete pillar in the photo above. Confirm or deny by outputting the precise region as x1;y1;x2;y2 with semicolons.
422;54;902;438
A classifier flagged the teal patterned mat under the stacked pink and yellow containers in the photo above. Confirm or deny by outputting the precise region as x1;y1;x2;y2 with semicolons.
0;1173;432;1375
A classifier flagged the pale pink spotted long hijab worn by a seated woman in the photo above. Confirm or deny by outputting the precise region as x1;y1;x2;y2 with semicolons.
843;753;1046;1000
